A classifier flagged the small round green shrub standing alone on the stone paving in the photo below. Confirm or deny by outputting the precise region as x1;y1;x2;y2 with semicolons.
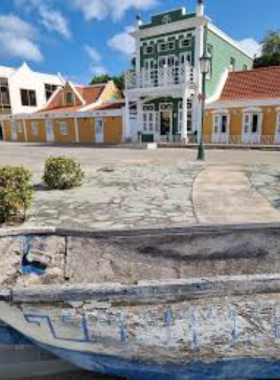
43;156;84;190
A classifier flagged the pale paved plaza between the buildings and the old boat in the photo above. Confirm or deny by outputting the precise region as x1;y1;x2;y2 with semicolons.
0;142;280;230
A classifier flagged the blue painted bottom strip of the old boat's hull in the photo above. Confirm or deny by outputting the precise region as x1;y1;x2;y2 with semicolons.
31;343;280;380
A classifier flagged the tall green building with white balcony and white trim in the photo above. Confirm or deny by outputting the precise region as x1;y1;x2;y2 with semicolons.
125;0;253;142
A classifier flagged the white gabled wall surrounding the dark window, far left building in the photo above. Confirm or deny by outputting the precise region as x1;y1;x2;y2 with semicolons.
0;64;63;114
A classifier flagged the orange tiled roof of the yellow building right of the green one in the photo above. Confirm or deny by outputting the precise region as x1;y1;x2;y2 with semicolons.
219;66;280;101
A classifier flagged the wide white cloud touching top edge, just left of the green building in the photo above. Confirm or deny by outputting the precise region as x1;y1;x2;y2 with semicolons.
73;0;159;20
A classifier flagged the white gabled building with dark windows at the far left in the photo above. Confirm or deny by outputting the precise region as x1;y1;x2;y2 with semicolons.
0;63;64;138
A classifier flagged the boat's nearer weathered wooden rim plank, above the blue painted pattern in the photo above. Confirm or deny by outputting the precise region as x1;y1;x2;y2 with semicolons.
12;275;280;304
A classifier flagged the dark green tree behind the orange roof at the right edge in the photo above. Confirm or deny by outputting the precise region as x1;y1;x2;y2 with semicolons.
254;31;280;69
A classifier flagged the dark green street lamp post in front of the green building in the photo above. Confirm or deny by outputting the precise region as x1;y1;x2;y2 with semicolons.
197;37;212;161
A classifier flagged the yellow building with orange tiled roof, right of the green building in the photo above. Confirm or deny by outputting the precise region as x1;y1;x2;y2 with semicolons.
204;67;280;144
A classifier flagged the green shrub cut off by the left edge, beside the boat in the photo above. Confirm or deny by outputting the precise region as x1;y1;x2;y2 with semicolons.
0;165;33;223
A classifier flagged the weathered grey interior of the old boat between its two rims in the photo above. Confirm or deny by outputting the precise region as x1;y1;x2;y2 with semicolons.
0;224;280;285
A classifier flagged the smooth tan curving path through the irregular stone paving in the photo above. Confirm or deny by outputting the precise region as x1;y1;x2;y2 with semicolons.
193;166;280;224
